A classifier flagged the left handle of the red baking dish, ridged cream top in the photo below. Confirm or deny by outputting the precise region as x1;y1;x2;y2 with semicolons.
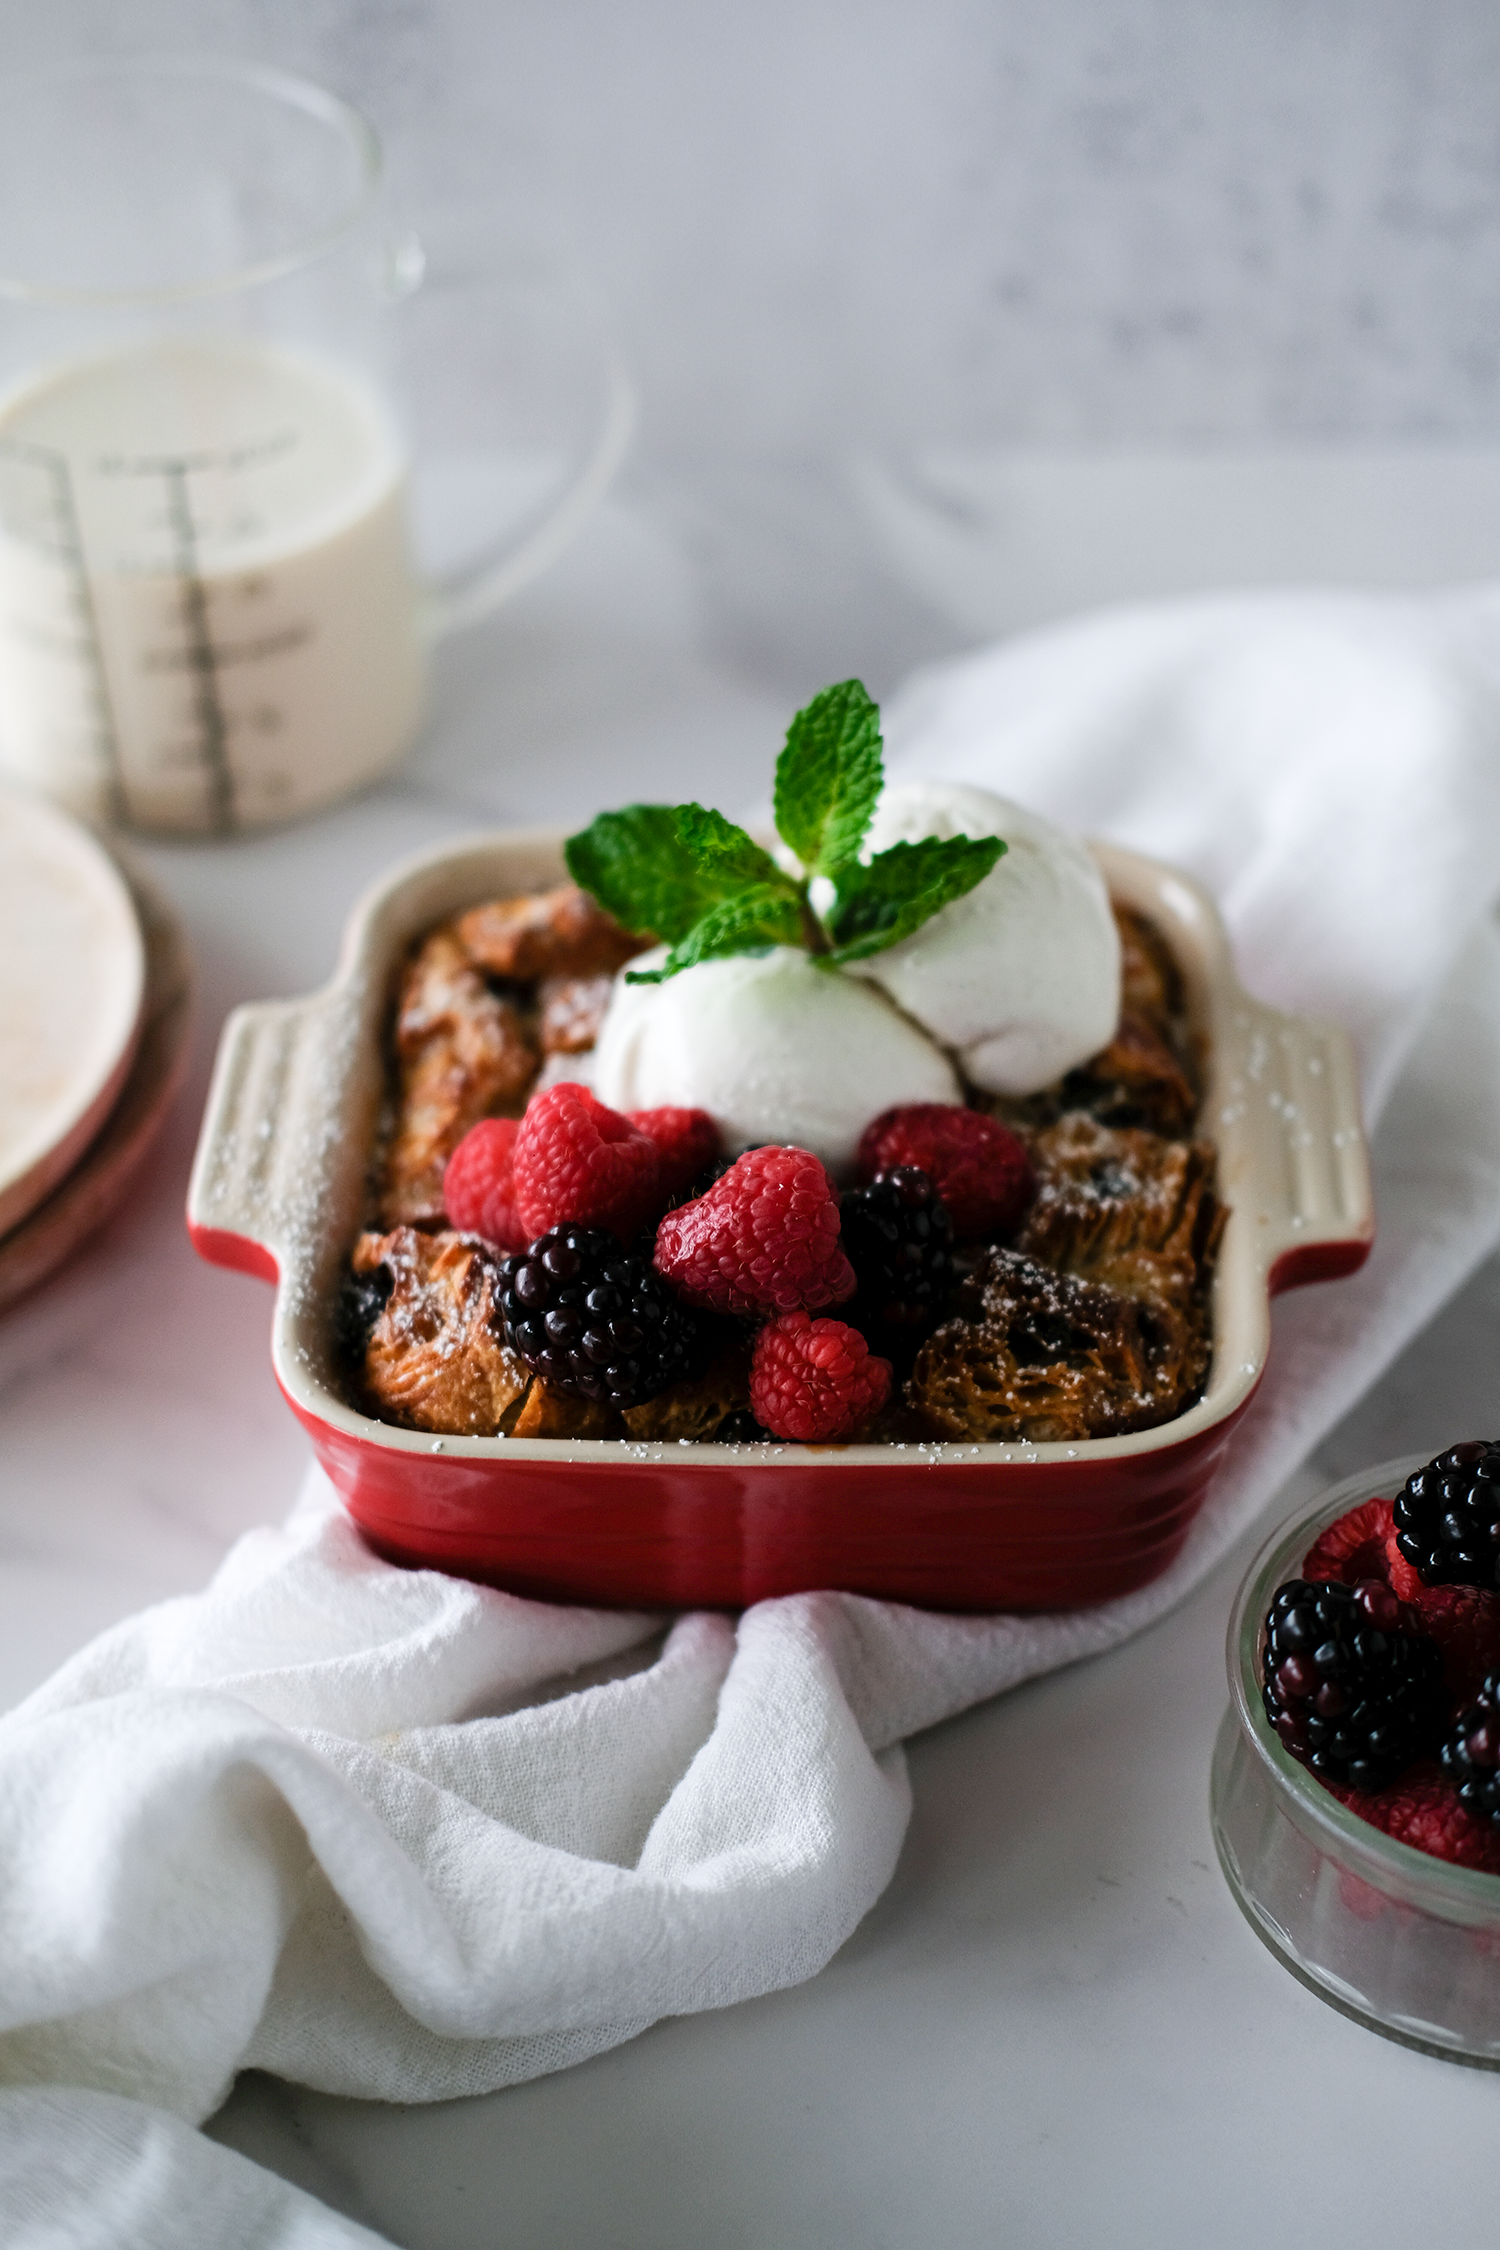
187;992;348;1283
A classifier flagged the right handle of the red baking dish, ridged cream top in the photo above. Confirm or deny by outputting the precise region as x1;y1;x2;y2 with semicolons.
1203;992;1374;1296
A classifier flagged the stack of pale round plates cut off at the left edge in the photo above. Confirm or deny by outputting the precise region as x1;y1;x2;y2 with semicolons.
0;792;189;1307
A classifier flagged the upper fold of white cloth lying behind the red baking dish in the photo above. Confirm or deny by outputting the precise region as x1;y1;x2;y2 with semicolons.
886;585;1500;1118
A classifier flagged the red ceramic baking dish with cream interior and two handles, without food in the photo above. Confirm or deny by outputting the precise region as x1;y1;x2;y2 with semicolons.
187;830;1374;1611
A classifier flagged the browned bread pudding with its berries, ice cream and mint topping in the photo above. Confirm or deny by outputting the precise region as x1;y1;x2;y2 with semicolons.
337;682;1223;1445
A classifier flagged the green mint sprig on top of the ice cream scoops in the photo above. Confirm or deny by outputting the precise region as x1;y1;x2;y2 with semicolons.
564;680;1005;983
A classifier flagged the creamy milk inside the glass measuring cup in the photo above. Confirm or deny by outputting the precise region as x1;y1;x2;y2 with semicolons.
0;340;425;833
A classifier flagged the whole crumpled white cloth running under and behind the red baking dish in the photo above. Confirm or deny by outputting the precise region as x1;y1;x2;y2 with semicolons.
0;592;1500;2250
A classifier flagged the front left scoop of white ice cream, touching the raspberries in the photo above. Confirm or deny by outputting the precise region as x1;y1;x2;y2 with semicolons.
594;945;963;1177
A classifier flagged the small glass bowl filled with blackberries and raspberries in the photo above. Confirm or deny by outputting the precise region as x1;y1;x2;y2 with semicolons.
1212;1447;1500;2068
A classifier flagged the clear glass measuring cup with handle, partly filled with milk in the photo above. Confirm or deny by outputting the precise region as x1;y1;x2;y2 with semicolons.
0;59;632;835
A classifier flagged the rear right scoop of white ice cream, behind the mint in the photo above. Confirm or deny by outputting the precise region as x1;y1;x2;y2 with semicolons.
855;781;1120;1094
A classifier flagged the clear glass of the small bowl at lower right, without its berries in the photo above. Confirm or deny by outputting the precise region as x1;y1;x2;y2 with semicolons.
1210;1454;1500;2070
